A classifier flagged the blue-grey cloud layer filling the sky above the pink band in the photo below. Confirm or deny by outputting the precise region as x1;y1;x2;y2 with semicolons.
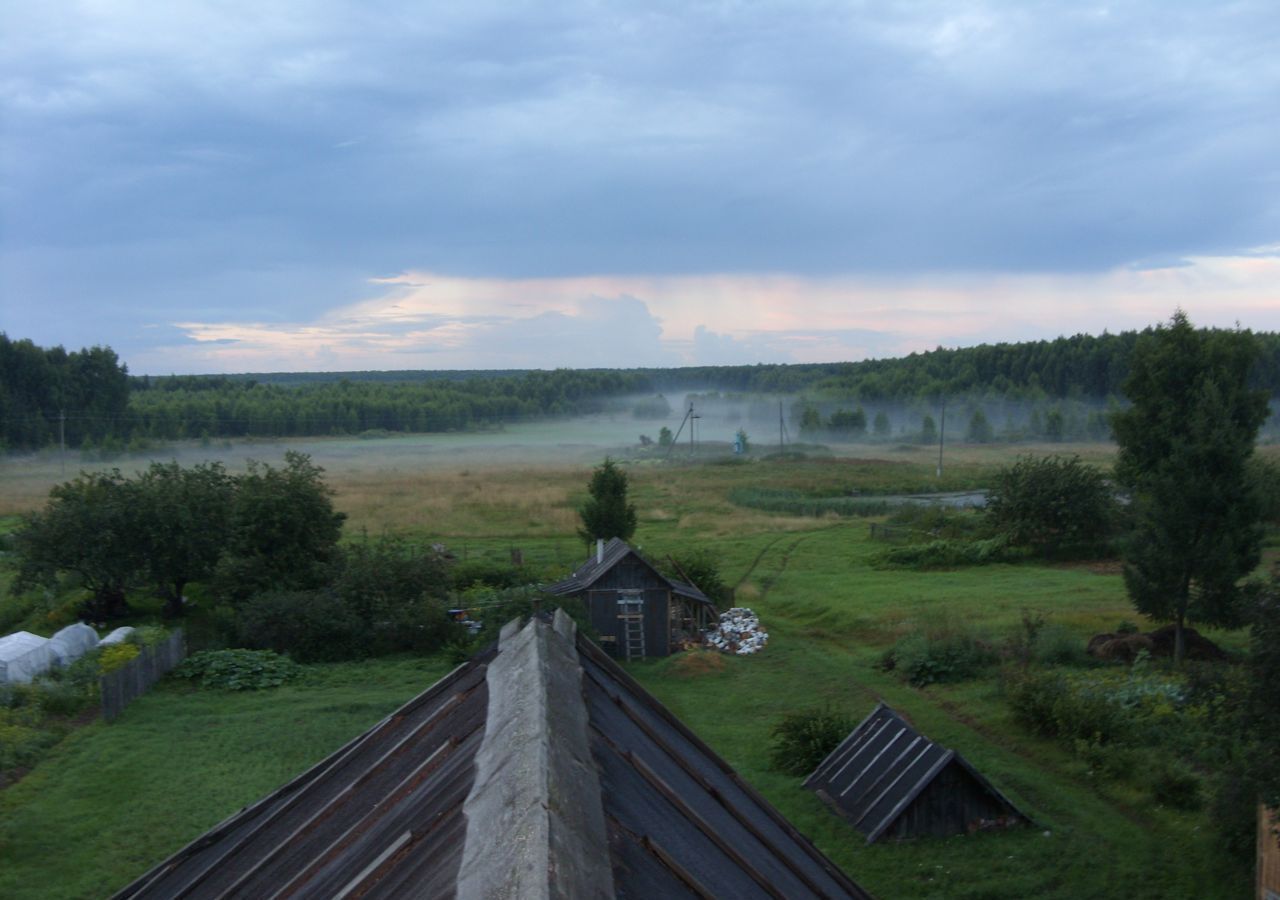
0;0;1280;363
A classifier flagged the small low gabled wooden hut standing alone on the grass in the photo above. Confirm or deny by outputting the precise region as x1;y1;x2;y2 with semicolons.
804;703;1030;844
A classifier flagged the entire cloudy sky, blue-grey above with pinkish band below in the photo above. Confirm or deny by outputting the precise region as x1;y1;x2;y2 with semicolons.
0;0;1280;374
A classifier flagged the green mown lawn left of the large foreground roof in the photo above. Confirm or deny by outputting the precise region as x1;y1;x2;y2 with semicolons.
0;654;452;900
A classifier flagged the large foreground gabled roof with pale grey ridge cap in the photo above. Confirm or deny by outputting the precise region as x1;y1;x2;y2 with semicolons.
118;611;868;897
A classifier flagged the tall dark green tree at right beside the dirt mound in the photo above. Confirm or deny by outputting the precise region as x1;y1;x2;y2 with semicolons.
1111;310;1267;662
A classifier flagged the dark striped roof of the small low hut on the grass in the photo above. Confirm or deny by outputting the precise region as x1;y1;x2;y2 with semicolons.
804;703;1025;844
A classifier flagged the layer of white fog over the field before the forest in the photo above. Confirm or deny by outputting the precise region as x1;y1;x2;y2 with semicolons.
0;390;1141;515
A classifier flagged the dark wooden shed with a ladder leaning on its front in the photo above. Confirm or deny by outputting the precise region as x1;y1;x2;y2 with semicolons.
547;538;716;659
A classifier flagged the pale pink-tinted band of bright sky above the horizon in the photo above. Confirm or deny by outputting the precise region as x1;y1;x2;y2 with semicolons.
157;252;1280;371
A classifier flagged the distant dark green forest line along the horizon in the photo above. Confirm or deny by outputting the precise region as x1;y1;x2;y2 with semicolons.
0;332;1280;449
